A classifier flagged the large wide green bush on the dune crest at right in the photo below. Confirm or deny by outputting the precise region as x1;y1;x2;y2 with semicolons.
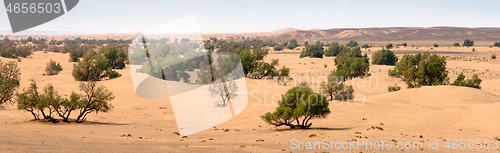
389;51;449;88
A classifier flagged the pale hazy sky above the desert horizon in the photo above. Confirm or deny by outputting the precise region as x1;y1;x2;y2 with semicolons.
0;0;500;33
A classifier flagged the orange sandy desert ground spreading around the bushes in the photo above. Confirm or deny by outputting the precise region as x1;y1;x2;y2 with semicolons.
0;47;500;152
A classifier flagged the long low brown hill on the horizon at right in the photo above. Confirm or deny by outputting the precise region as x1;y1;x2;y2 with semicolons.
267;27;500;41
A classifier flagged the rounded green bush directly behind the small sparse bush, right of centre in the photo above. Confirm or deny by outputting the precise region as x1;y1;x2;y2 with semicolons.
335;46;370;80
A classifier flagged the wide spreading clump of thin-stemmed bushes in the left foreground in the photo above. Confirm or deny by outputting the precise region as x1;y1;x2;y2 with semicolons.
17;82;114;123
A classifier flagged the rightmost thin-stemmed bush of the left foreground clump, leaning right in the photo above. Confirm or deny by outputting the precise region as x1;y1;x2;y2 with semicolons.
76;82;115;123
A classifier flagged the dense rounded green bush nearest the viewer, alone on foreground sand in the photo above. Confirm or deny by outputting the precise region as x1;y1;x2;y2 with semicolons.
260;85;330;129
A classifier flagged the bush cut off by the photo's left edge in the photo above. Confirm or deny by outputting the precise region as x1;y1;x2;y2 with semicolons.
0;61;21;105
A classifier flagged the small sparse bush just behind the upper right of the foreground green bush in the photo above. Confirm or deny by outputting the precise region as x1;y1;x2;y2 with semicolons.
321;70;354;101
